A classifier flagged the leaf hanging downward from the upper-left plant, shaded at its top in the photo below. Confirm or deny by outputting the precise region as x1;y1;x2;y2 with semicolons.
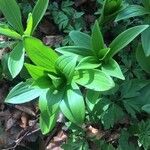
8;42;25;78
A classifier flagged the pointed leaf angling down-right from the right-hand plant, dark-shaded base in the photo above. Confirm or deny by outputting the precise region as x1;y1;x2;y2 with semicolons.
101;59;125;80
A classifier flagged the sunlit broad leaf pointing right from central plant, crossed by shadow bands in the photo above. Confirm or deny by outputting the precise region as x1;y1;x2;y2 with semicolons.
74;69;115;91
